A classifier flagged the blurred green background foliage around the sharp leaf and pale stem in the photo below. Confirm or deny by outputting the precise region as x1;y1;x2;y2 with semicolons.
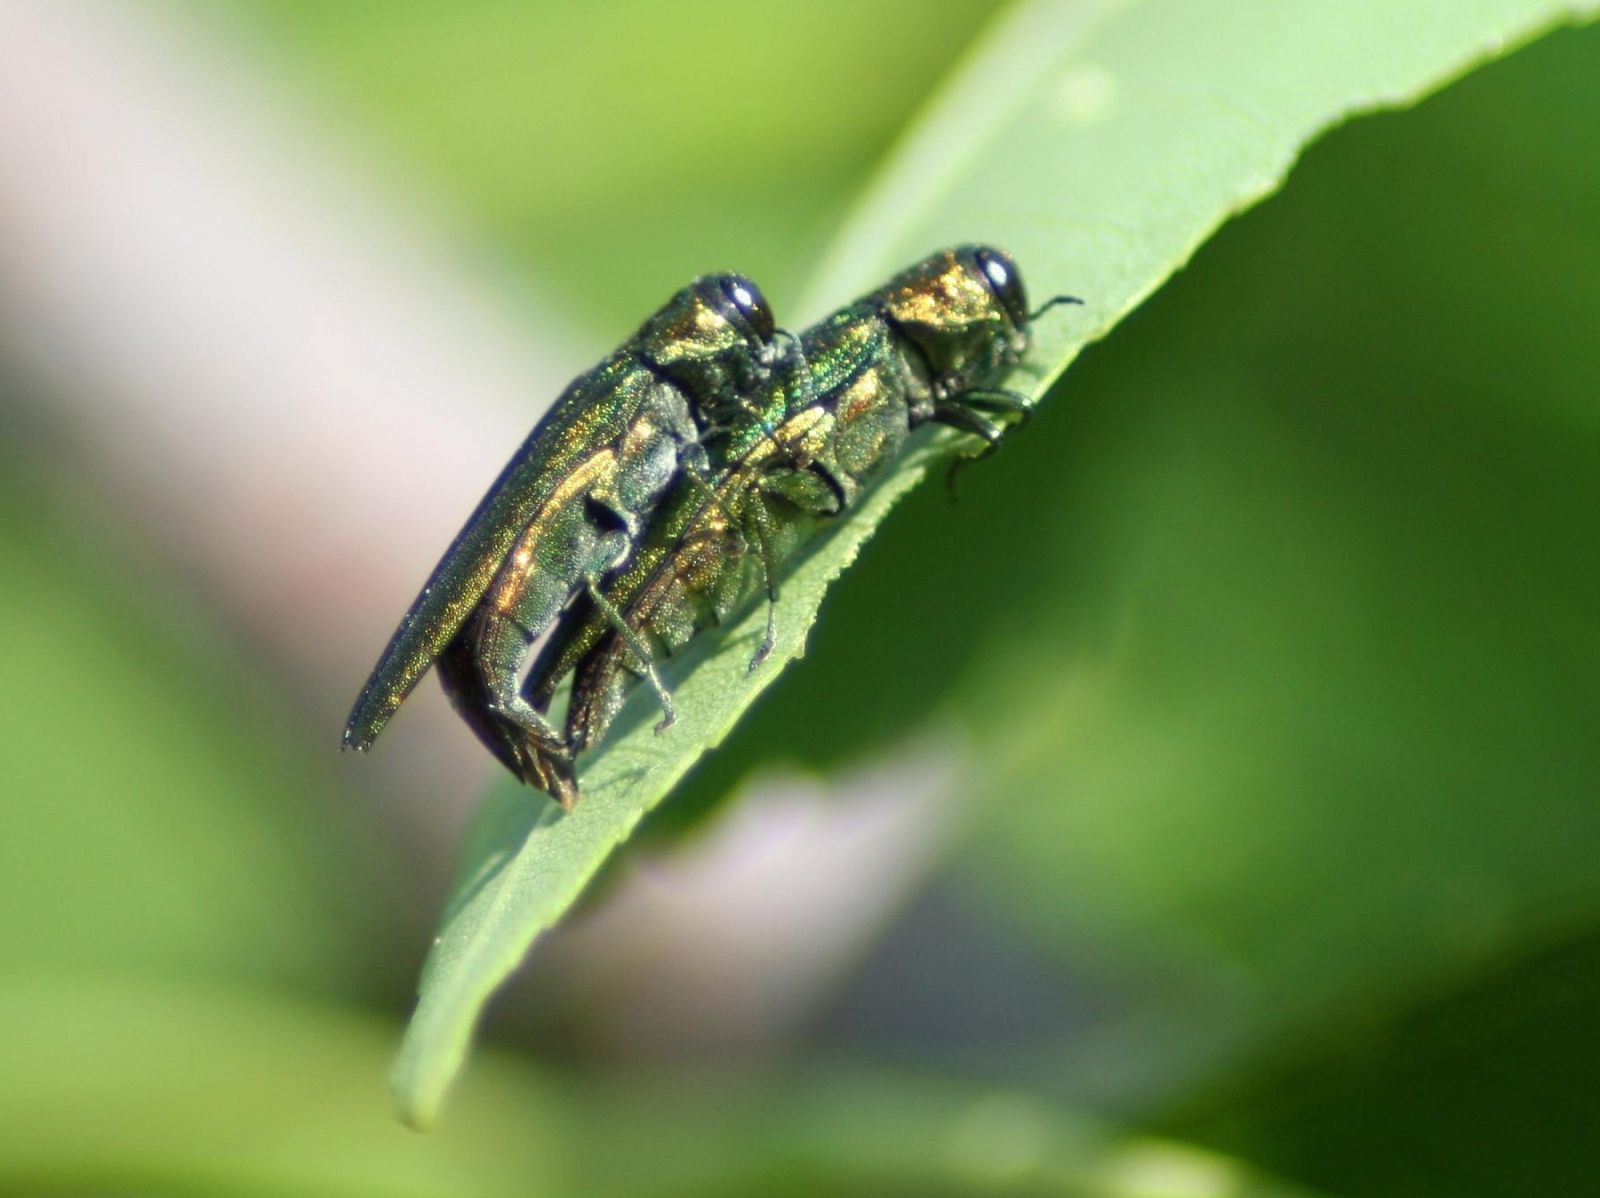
0;0;1600;1196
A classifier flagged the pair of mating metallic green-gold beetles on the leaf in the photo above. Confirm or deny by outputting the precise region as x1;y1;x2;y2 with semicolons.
344;246;1077;806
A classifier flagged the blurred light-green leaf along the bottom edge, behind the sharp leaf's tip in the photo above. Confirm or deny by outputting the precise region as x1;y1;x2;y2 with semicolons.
0;971;1310;1198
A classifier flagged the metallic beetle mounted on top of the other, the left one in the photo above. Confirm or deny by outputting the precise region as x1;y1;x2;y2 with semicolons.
344;275;803;798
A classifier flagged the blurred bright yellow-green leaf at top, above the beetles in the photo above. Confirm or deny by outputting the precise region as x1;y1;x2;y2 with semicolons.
220;0;998;323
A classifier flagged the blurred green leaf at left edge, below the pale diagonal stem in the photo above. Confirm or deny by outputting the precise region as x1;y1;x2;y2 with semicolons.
0;438;395;993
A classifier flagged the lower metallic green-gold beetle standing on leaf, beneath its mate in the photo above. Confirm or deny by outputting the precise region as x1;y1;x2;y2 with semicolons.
523;246;1078;792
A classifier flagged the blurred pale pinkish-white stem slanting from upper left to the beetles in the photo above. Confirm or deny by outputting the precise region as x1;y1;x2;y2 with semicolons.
0;0;582;806
